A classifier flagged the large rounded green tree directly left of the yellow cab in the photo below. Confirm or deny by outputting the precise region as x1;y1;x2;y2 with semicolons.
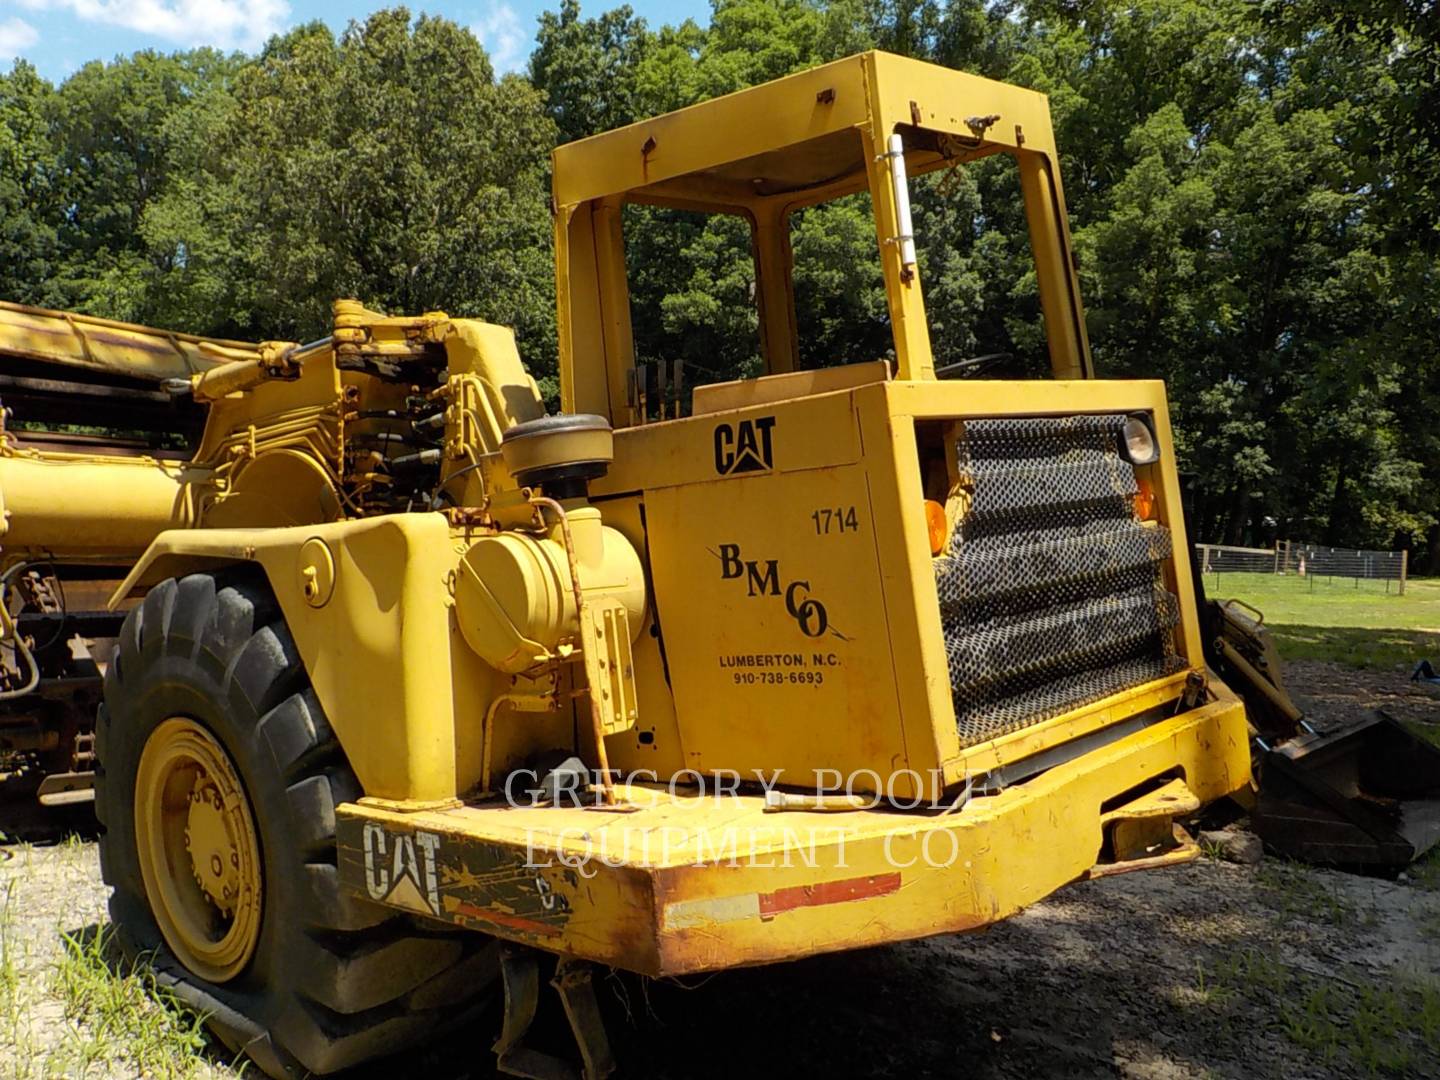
147;9;554;376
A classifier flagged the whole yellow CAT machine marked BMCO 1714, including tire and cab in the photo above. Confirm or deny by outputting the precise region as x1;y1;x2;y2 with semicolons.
0;53;1250;1076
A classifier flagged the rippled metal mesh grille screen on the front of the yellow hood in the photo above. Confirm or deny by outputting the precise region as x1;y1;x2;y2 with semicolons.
935;416;1184;746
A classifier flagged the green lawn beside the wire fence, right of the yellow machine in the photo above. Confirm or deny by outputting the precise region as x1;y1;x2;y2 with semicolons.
1205;573;1440;671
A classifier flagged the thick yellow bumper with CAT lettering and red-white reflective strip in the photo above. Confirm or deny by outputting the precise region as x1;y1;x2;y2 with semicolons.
338;687;1250;975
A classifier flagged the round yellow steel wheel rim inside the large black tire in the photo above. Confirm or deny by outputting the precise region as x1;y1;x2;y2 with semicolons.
135;717;262;982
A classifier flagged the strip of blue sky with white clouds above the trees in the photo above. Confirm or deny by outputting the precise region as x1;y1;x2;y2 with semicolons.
0;0;710;81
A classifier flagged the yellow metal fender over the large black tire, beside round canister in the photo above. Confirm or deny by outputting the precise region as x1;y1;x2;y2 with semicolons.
112;514;483;801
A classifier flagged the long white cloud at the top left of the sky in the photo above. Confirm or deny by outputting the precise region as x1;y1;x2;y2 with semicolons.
19;0;289;49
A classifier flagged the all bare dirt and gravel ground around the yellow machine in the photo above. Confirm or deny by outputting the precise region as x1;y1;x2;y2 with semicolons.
0;664;1440;1080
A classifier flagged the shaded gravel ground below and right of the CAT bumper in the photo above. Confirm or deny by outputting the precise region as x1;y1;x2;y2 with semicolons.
613;860;1440;1080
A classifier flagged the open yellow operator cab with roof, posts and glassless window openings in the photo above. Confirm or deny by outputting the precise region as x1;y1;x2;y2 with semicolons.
556;53;1090;428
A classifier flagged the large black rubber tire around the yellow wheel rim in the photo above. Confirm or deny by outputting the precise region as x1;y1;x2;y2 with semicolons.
95;567;498;1079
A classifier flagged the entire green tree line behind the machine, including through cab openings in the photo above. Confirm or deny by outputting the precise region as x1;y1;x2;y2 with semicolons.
0;0;1440;564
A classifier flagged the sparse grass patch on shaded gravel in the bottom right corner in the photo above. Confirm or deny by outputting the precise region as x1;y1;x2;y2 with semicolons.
1198;949;1440;1076
